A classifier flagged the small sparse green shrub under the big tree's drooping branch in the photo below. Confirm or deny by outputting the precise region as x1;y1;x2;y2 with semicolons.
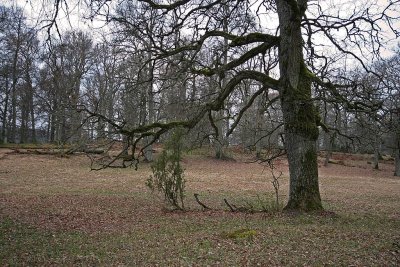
146;128;185;210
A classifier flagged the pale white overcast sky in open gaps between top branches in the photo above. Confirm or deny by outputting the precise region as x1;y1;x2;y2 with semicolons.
6;0;400;60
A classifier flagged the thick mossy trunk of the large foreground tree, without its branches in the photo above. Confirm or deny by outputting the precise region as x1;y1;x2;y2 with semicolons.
276;0;322;211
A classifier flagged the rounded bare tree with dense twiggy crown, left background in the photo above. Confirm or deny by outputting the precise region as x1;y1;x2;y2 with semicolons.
41;31;92;143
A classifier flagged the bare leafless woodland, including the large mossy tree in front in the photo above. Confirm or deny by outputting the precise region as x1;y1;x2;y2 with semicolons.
0;0;400;214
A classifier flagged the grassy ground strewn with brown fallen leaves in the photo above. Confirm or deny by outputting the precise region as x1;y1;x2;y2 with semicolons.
0;149;400;266
